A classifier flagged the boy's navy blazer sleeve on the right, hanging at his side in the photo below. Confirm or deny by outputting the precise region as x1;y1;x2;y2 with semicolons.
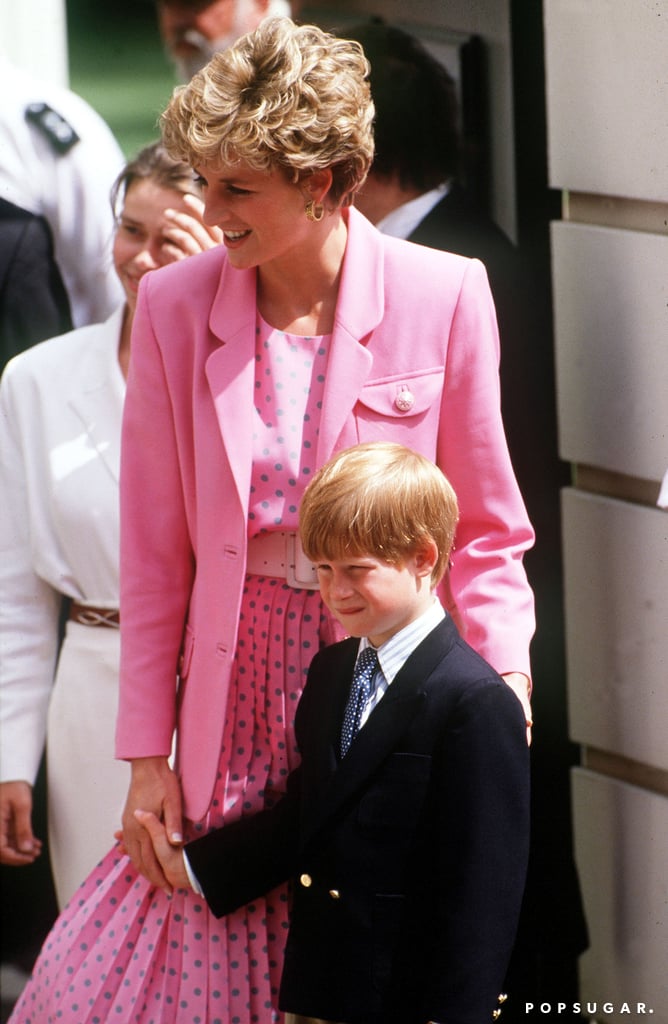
425;681;529;1024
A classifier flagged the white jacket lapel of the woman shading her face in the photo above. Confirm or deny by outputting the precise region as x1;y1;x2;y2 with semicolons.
68;307;123;483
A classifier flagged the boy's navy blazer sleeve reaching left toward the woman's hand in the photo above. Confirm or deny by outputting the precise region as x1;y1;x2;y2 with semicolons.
185;768;301;918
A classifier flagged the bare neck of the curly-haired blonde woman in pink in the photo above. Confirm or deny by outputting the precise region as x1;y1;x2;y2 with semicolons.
257;211;347;335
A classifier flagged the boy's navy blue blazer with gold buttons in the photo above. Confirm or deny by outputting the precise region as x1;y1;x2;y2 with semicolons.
187;618;529;1024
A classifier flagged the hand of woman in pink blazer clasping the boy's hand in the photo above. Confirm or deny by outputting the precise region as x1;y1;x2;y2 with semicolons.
123;757;182;889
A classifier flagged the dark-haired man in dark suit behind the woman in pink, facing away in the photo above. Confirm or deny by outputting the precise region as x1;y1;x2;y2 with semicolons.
341;18;588;1024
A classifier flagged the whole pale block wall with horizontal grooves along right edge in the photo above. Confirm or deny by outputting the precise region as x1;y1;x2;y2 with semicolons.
544;0;668;1024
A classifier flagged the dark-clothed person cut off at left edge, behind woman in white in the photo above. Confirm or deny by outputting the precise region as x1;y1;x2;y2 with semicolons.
0;198;72;370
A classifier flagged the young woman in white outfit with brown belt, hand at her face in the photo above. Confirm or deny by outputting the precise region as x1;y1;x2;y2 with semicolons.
0;143;219;906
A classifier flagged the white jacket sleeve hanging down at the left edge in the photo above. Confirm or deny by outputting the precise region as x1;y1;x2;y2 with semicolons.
0;356;60;784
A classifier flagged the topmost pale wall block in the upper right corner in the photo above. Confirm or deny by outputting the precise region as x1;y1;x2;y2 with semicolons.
544;0;668;203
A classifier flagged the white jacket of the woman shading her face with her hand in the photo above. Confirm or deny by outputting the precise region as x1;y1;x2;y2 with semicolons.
0;307;125;783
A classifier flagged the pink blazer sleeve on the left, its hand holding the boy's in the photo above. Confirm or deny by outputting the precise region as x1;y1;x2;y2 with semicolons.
116;274;195;759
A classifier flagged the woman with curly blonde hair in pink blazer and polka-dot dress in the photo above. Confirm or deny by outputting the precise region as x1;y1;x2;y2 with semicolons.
9;18;534;1024
